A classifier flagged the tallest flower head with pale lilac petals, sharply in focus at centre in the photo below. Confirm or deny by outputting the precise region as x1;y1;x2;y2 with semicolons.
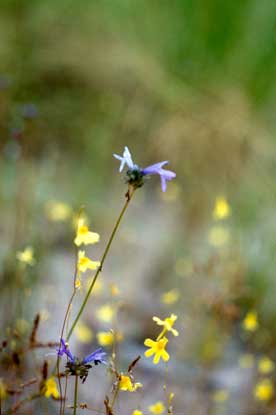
113;147;176;192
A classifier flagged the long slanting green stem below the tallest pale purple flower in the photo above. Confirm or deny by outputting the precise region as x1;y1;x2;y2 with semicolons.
66;189;134;341
